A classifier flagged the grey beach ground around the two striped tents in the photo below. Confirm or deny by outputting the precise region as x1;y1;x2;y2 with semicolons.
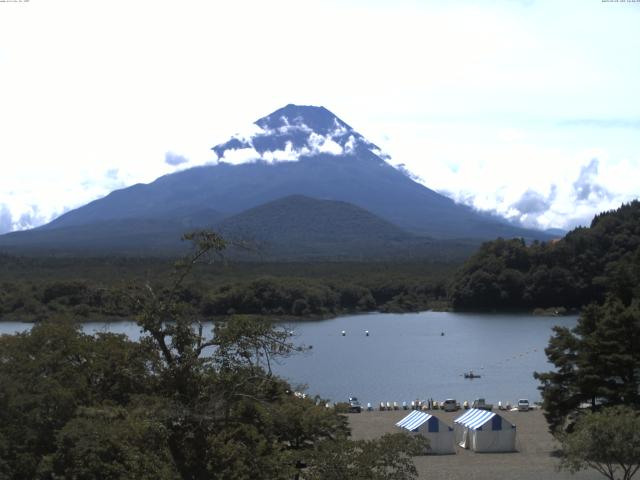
348;410;602;480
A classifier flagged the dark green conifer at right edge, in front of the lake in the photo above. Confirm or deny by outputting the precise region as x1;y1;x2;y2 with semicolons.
535;298;640;433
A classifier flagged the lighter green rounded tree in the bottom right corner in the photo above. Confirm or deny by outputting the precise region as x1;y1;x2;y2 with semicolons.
560;406;640;480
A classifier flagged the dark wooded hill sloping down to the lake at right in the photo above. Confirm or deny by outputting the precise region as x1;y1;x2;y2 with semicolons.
450;201;640;310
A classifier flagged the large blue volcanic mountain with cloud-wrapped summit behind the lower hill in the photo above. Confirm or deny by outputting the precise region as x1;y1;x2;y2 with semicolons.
0;105;547;251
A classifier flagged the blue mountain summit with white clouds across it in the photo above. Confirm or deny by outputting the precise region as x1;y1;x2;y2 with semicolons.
212;104;389;165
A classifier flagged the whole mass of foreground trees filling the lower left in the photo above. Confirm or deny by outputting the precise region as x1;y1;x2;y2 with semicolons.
0;232;424;480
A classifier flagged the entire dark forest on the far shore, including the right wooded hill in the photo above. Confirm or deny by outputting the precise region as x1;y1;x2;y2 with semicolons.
5;201;640;321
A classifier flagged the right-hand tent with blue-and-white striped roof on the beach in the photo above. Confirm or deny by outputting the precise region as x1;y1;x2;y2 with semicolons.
453;408;516;452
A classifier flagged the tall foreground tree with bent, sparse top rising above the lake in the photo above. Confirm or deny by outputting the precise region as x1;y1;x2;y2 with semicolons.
132;232;292;480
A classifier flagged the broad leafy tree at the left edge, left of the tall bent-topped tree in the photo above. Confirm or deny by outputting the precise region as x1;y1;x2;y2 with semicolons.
0;318;155;479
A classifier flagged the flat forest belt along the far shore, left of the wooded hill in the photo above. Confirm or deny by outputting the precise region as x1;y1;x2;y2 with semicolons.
0;255;458;321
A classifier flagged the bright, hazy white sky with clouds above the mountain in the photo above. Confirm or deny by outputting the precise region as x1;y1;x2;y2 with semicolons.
0;0;640;232
